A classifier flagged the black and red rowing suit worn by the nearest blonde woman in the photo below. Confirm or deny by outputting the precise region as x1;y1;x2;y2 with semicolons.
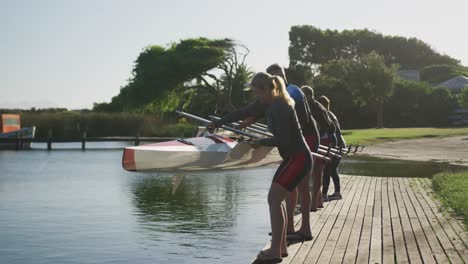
258;98;312;191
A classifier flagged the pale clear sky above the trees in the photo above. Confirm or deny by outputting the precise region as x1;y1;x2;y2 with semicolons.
0;0;468;109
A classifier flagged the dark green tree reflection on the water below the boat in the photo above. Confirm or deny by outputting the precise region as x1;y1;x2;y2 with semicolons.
133;173;242;234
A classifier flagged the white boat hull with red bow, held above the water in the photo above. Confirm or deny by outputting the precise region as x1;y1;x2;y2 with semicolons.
122;134;281;172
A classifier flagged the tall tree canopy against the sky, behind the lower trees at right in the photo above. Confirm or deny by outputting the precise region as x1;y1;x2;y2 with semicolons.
289;25;459;70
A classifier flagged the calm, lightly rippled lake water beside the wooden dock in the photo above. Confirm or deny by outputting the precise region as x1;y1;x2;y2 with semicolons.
0;143;460;263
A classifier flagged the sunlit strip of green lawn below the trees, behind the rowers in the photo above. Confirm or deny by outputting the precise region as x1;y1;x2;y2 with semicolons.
343;127;468;145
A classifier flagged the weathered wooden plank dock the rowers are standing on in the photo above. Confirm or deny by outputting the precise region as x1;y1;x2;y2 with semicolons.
256;176;468;264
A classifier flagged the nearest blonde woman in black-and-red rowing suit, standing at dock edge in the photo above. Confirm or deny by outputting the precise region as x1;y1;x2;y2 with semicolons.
251;73;312;263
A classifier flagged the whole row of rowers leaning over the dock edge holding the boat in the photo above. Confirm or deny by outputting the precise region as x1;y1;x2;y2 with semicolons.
208;64;346;263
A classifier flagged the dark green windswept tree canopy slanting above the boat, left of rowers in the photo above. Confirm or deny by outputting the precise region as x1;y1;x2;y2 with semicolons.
95;38;234;111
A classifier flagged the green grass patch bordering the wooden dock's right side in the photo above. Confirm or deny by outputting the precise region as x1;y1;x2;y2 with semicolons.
432;171;468;231
